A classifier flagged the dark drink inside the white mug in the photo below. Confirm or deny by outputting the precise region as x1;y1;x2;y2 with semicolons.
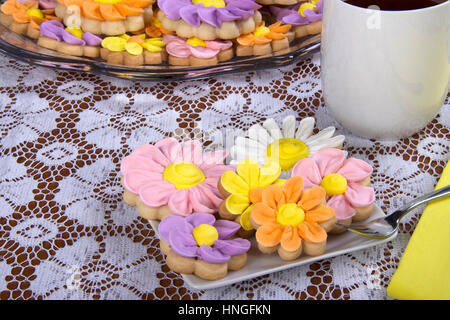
345;0;447;11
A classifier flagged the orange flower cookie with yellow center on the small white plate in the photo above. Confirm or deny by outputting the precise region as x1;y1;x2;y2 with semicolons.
250;177;337;260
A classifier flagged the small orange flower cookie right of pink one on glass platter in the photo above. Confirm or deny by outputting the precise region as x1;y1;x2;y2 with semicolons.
236;21;295;56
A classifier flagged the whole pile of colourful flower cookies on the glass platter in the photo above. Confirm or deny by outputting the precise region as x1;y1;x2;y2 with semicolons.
0;0;322;66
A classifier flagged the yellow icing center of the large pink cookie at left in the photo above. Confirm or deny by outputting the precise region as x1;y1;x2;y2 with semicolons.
163;161;205;189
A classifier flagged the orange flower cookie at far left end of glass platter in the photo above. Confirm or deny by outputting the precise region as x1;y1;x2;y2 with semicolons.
0;0;59;39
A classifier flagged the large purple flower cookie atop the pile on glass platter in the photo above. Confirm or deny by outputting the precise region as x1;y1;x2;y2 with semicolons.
157;0;262;40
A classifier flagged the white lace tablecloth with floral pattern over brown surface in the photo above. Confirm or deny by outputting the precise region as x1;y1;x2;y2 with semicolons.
0;55;450;299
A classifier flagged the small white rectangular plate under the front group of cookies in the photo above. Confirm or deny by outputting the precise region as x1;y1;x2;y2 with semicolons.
149;205;397;290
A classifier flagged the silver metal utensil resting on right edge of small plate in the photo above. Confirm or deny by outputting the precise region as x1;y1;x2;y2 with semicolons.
336;185;450;239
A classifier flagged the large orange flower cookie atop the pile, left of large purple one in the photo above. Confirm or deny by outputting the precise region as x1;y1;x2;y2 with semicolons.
55;0;155;36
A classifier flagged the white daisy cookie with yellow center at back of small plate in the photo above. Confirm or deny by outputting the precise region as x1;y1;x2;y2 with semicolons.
230;116;345;177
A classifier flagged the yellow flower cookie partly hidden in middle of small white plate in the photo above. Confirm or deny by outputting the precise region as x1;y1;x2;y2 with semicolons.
218;159;281;231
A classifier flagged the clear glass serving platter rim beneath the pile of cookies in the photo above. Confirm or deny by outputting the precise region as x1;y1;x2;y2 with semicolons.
0;18;320;81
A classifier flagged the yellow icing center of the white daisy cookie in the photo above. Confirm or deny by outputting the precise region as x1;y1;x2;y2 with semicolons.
266;138;309;170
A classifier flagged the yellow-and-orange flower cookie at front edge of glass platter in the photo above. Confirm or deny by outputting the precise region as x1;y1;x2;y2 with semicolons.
100;34;167;66
